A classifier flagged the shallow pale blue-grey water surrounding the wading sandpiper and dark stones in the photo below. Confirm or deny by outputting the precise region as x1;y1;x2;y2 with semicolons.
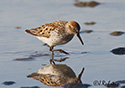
0;0;125;88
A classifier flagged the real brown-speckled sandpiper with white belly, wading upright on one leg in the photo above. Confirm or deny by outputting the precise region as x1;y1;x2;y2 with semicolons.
25;20;84;57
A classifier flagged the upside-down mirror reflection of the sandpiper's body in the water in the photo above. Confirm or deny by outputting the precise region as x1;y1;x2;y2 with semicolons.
27;57;84;88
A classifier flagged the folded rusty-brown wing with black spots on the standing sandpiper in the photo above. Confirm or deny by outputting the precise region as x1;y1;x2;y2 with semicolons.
25;21;67;38
